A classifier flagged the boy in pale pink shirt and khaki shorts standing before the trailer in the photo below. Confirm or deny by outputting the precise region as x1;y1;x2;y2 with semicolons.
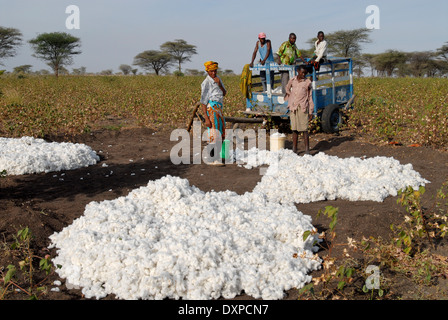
285;65;314;154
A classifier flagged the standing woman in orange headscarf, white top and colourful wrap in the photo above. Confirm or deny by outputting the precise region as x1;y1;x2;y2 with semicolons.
201;61;227;165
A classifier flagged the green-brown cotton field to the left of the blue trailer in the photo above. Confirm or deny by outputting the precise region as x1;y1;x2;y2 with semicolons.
0;76;244;137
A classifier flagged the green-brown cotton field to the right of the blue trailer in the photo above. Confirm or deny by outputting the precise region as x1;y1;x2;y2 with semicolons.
349;78;448;149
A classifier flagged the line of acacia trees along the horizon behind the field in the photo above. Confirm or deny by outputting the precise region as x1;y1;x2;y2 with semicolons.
0;26;448;77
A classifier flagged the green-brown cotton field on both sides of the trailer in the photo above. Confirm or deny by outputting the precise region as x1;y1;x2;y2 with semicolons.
0;75;448;149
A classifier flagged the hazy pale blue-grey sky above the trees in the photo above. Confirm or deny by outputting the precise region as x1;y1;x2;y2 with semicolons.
0;0;448;73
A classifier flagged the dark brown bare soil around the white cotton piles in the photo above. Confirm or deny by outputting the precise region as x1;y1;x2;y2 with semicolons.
0;124;448;300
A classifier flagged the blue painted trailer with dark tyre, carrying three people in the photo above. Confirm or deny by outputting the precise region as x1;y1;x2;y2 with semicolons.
243;57;355;133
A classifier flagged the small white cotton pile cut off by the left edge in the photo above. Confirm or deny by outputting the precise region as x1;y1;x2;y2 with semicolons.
0;137;100;175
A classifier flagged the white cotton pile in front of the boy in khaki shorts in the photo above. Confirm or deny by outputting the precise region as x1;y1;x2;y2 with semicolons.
234;148;429;203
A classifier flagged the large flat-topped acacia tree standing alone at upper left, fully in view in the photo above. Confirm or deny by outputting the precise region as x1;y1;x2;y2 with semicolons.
29;32;81;77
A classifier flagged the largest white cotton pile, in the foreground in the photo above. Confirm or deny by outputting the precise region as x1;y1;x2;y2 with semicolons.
50;176;320;299
